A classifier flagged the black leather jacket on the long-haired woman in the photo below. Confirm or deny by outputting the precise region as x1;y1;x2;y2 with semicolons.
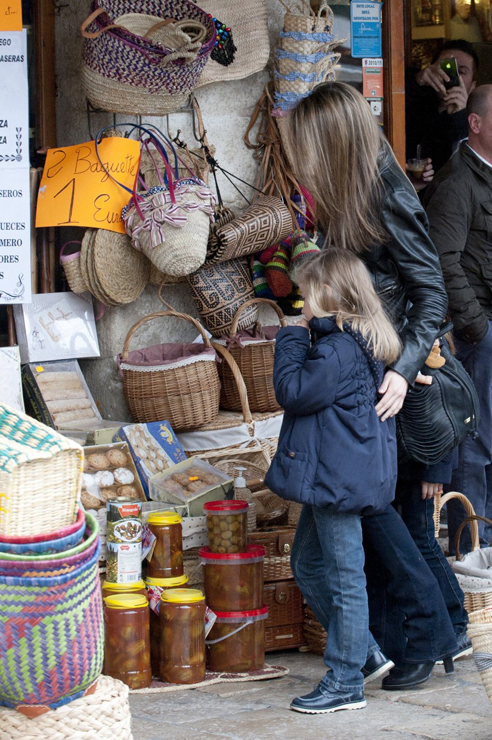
360;149;448;384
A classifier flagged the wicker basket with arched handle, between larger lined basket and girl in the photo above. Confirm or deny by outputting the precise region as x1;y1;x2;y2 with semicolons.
217;298;287;412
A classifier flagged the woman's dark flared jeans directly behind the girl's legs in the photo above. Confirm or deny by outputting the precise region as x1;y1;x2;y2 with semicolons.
362;505;457;665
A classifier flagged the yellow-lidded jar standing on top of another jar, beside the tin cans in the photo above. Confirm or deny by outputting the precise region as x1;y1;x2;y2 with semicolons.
147;511;183;578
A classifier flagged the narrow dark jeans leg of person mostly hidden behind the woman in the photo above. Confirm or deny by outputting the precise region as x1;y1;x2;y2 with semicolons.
396;480;468;635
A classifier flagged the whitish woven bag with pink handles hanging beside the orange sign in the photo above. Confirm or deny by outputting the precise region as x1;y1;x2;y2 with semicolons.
122;129;215;277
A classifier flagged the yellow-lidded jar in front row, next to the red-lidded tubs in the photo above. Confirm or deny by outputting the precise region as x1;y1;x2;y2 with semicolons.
159;588;205;684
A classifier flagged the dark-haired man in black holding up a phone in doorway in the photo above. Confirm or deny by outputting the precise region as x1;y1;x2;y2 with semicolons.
405;39;478;187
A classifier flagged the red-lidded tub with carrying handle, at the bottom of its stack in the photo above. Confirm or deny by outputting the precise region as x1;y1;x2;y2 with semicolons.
206;606;268;673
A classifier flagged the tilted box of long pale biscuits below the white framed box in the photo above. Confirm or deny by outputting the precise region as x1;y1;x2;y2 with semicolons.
22;360;102;430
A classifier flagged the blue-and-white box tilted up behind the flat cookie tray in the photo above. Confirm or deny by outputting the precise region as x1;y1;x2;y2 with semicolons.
113;421;187;497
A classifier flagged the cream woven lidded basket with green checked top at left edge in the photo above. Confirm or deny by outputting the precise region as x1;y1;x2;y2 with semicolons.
0;404;83;537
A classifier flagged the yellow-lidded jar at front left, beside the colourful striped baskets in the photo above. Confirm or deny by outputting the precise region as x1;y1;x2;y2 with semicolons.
103;594;152;689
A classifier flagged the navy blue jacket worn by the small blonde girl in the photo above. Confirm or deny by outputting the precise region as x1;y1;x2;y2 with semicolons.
265;318;397;514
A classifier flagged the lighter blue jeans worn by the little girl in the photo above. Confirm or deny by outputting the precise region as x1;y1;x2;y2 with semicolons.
291;504;378;692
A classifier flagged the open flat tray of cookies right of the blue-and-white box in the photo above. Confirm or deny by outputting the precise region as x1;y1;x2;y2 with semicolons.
149;457;234;517
